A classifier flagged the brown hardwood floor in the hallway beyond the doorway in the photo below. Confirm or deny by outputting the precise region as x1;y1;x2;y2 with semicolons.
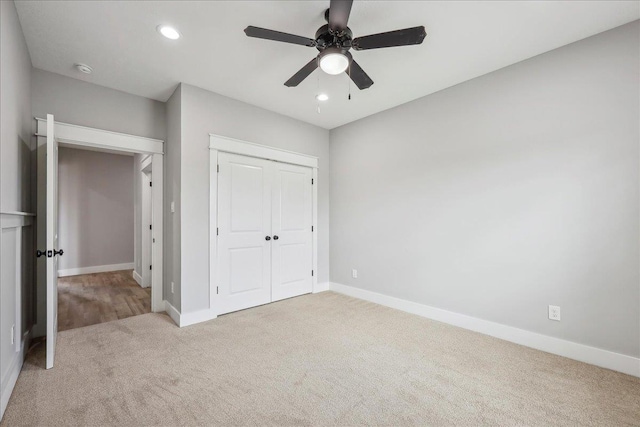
58;270;151;331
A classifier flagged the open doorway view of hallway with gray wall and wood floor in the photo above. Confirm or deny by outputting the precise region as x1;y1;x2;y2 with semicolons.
58;146;151;331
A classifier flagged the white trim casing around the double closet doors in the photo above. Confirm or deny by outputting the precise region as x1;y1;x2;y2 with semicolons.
209;133;320;314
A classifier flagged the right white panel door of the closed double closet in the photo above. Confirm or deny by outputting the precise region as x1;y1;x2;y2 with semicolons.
271;163;313;301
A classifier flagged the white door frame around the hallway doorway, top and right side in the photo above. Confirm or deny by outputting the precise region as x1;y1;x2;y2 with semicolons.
35;117;165;312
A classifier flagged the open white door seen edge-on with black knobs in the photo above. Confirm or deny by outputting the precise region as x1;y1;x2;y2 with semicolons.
45;114;59;369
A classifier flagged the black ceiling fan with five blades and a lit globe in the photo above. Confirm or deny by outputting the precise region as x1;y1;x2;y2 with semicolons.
244;0;427;89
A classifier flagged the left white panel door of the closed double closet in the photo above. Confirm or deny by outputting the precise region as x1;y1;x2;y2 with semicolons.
218;153;273;314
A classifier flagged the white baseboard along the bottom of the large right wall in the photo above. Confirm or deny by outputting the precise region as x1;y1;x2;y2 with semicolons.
329;282;640;377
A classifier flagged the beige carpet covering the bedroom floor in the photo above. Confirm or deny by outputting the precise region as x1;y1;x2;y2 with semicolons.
2;292;640;426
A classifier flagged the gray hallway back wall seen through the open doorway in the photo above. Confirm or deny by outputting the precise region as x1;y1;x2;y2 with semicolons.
58;148;134;270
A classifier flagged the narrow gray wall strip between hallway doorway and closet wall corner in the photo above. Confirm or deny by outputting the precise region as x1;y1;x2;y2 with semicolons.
163;86;182;310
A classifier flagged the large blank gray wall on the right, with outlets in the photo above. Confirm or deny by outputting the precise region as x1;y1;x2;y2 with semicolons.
331;21;640;357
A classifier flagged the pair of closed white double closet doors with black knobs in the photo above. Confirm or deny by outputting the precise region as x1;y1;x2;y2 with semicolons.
217;153;313;314
